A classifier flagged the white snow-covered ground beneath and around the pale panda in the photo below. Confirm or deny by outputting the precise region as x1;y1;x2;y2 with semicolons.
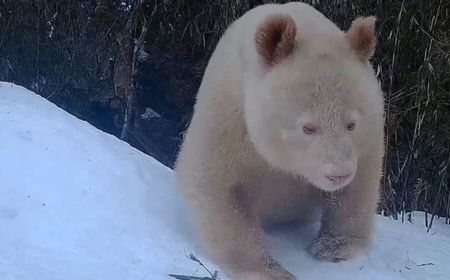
0;83;450;280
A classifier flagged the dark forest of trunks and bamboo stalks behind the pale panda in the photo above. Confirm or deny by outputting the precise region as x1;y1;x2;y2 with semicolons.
0;0;450;226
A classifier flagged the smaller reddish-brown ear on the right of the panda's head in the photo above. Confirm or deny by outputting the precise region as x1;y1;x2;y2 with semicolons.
345;16;377;61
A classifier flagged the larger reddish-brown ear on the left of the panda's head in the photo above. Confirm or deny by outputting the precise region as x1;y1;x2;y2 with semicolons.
255;15;297;67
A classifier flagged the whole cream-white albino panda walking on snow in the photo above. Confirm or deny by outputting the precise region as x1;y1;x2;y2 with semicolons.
175;3;384;280
